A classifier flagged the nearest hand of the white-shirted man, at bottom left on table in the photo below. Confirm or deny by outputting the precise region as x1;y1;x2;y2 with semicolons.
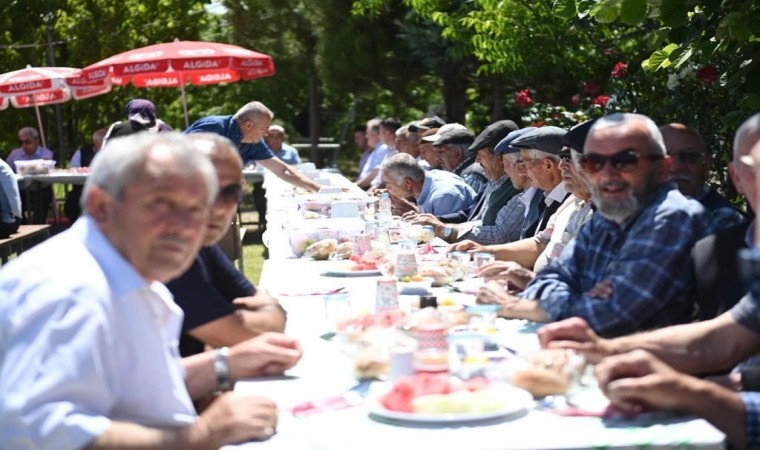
193;392;277;448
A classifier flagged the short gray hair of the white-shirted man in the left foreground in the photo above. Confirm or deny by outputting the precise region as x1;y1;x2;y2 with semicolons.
80;133;219;210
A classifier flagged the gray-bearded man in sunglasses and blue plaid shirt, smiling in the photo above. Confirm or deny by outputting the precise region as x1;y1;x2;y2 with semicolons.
478;114;714;336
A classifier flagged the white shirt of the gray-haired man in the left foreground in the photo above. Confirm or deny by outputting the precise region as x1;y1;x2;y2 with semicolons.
0;216;196;449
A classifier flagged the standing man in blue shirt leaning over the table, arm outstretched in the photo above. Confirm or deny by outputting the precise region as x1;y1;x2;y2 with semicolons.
183;102;320;192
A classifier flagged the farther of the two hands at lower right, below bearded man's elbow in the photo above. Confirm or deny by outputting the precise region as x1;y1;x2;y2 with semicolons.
537;317;612;363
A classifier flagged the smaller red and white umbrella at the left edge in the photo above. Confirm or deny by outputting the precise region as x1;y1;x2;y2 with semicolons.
0;66;111;147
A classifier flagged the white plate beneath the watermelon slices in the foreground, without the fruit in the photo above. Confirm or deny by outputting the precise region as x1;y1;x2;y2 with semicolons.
369;387;533;423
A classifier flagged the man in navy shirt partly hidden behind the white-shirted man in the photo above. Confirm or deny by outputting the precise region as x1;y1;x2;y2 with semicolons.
167;133;285;356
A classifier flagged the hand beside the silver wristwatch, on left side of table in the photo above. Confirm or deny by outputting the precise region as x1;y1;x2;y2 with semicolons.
229;332;303;380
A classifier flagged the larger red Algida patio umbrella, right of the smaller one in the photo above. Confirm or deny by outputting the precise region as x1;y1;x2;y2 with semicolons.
83;40;275;127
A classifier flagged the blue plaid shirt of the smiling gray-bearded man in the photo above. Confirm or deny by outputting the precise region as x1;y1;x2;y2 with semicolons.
520;183;714;336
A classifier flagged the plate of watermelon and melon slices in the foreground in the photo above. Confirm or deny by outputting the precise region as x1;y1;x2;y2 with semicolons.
369;373;533;423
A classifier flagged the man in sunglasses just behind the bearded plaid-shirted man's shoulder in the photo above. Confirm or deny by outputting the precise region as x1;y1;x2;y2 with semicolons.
660;123;747;229
